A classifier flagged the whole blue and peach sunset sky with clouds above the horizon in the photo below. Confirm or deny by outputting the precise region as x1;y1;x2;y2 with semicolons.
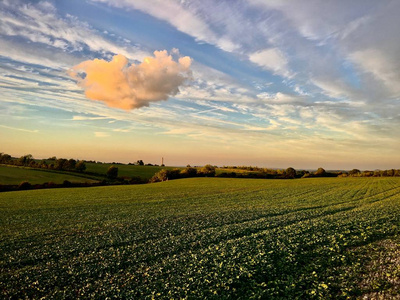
0;0;400;170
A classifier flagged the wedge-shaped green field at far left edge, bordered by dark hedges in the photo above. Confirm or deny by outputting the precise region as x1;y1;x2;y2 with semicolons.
0;166;97;185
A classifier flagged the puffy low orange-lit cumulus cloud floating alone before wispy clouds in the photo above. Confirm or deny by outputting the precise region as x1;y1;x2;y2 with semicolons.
68;50;192;110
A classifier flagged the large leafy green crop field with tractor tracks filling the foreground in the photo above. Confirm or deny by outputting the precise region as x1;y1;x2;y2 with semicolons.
0;177;400;299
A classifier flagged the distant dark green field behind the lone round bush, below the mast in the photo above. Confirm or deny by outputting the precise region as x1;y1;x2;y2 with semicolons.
86;163;174;180
